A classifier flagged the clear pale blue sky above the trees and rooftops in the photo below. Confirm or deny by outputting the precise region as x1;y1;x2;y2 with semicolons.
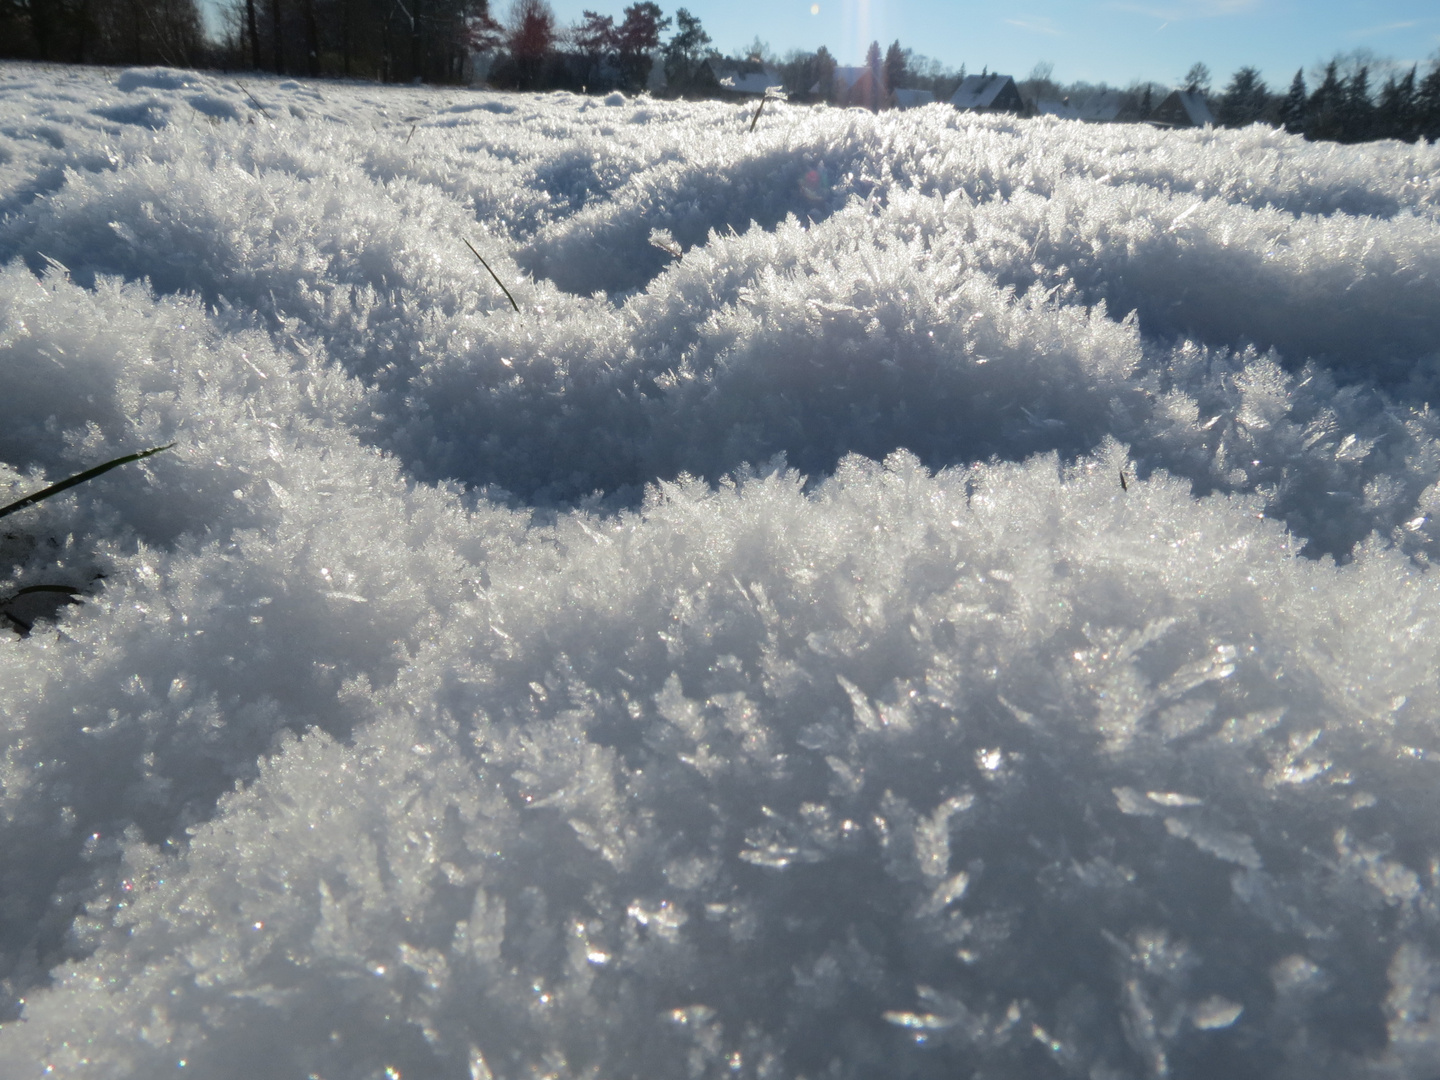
541;0;1440;86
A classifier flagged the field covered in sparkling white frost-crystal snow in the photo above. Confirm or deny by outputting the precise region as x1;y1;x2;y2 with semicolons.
0;65;1440;1080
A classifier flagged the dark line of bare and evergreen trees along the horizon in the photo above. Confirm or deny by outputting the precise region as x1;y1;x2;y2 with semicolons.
0;0;1440;143
